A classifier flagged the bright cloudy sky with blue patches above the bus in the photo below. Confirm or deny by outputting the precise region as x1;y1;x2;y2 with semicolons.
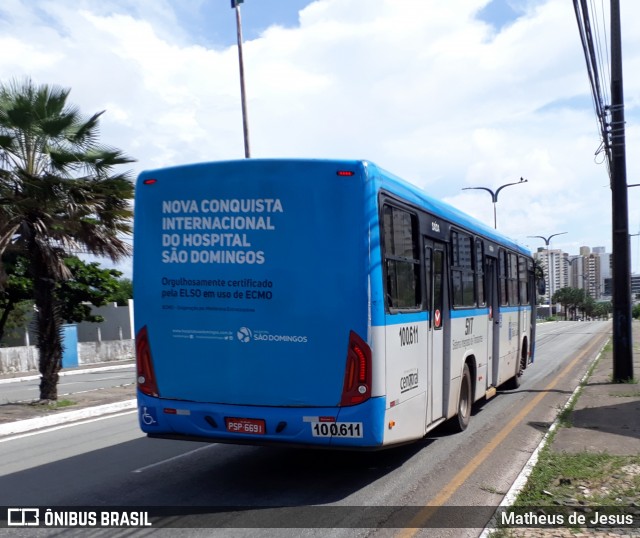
0;0;640;275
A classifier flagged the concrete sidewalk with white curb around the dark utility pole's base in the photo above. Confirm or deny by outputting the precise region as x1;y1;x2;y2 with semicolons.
481;321;640;538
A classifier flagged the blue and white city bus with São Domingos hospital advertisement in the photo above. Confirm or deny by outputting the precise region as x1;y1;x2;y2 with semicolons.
133;159;535;448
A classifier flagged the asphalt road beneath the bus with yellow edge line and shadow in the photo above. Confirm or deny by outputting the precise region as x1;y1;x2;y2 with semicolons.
0;322;611;538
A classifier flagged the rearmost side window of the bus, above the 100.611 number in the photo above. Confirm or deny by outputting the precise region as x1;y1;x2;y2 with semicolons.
382;205;422;310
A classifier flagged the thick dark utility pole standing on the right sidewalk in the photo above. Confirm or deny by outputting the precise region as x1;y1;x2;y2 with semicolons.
611;0;633;376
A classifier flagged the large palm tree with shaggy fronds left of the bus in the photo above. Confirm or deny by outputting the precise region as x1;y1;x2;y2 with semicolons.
0;79;133;400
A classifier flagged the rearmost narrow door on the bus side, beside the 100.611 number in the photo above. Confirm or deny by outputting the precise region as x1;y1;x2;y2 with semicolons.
425;239;449;425
